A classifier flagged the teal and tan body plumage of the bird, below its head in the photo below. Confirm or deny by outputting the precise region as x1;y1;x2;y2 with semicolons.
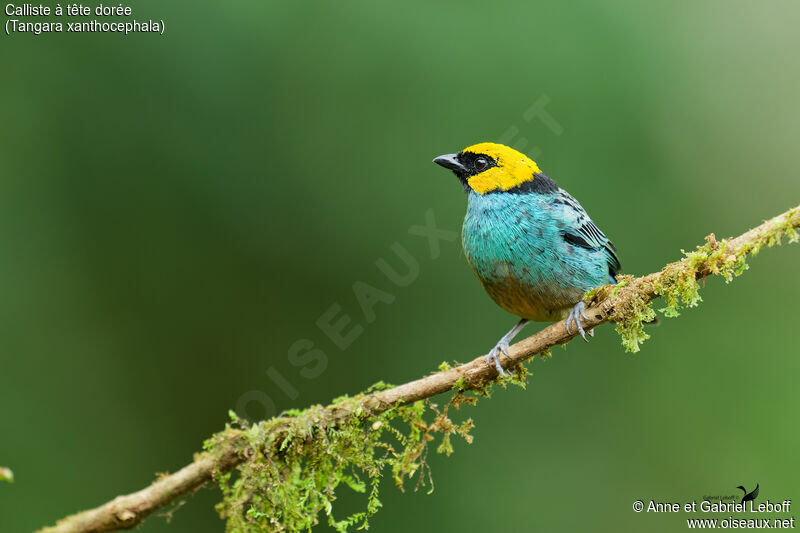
462;189;619;322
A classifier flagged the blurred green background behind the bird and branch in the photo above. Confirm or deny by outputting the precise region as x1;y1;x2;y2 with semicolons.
0;0;800;533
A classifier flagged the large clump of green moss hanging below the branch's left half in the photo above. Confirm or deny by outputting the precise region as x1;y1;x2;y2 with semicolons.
205;383;476;533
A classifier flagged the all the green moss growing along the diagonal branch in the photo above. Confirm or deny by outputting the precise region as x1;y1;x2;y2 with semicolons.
205;209;798;533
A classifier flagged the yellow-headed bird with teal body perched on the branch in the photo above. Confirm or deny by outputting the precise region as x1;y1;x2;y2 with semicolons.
433;142;620;377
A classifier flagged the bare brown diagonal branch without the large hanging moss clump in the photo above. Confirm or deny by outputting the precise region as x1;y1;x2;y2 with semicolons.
40;205;800;533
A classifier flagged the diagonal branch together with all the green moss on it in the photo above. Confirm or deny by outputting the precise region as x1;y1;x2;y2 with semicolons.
34;206;800;533
